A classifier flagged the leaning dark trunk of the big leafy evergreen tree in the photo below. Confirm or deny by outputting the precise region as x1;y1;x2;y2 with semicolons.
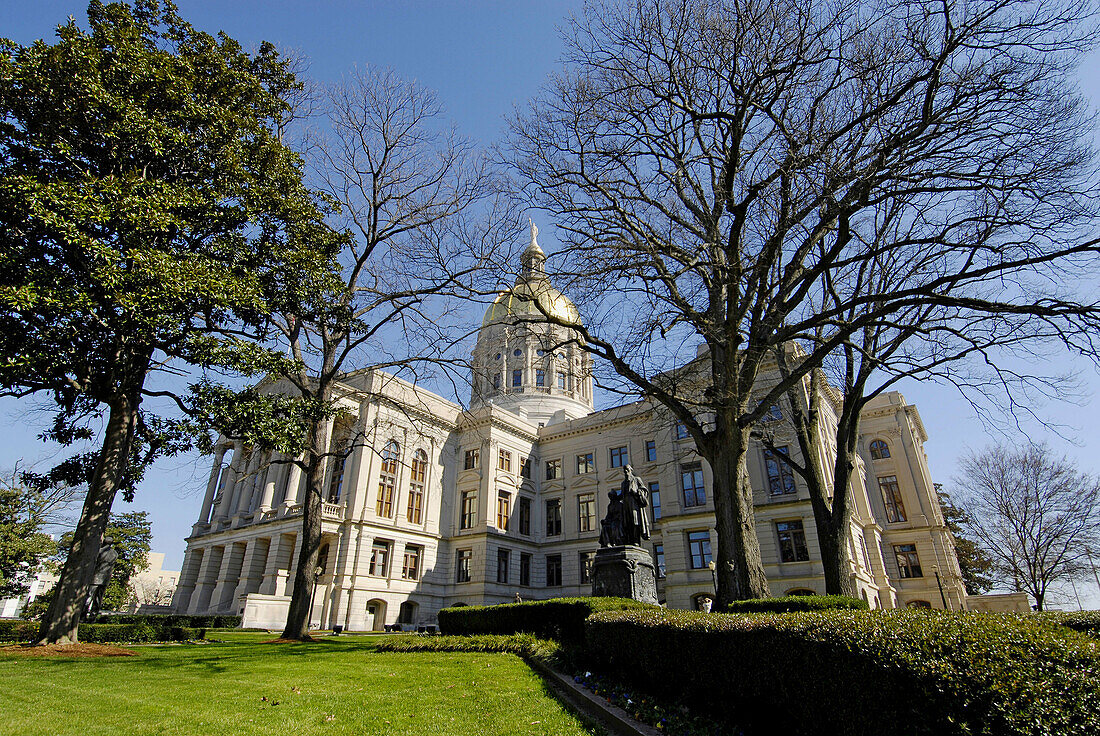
39;389;141;644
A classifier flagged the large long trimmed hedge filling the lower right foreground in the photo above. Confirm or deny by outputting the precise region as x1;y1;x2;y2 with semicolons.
585;611;1100;736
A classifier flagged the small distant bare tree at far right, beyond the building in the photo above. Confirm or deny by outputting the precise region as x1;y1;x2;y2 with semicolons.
955;443;1100;611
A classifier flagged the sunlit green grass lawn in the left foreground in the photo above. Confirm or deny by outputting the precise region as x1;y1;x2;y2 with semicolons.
0;633;591;736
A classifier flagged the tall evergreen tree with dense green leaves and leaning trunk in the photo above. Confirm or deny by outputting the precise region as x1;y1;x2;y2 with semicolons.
0;0;330;642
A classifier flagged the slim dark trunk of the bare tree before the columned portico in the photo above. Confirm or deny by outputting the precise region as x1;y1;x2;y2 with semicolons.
283;417;331;641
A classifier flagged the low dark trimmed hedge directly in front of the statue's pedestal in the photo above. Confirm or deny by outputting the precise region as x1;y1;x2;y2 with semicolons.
439;597;657;641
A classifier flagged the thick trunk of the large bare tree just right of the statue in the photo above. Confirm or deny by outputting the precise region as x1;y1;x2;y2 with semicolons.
704;418;770;611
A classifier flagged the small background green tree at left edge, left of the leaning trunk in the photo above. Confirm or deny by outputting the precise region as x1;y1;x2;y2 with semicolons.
0;485;55;598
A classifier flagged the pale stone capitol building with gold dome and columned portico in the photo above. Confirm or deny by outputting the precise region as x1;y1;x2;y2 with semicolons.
173;228;977;630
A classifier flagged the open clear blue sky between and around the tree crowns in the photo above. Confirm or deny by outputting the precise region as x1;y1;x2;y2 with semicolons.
0;0;1100;607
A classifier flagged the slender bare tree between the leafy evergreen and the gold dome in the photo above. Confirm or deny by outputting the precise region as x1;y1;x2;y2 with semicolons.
264;68;514;639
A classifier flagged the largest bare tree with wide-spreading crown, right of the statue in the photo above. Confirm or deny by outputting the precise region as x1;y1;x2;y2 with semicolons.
512;0;1093;606
